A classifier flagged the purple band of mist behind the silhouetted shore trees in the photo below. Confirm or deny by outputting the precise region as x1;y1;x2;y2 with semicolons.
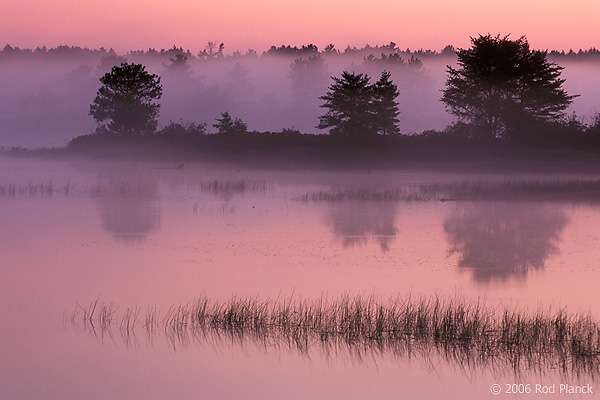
0;48;600;148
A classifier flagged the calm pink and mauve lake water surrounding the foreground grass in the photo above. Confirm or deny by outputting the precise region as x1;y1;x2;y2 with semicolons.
0;158;600;399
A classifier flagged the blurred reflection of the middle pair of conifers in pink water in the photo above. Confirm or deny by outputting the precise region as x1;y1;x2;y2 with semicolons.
328;201;398;251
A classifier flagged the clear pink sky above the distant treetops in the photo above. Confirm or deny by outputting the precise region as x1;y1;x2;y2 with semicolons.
0;0;600;53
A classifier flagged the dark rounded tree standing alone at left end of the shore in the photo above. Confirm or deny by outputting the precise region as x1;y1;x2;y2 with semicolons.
90;63;162;135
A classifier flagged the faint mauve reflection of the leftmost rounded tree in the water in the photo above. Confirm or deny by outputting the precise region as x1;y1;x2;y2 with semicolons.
96;172;161;244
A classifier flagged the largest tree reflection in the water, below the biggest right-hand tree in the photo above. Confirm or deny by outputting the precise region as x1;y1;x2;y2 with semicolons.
444;202;567;282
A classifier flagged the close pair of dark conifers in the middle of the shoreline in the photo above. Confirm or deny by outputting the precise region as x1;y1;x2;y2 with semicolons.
317;71;399;137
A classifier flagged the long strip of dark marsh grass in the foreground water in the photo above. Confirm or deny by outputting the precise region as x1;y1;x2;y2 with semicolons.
71;295;600;375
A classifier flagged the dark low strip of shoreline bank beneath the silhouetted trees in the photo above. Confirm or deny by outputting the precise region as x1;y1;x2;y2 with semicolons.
0;133;600;173
